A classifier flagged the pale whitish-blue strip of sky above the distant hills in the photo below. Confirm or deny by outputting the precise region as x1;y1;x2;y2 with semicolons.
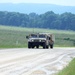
0;0;75;6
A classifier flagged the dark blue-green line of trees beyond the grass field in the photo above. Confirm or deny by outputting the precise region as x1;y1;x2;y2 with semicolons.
0;11;75;31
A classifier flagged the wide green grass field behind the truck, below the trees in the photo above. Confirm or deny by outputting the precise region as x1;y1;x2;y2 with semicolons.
0;25;75;48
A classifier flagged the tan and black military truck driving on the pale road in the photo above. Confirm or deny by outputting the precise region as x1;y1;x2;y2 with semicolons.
26;33;55;49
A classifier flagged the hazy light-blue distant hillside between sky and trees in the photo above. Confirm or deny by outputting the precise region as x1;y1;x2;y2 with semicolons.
0;3;75;14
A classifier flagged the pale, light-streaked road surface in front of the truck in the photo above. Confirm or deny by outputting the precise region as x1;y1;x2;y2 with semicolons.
0;48;75;75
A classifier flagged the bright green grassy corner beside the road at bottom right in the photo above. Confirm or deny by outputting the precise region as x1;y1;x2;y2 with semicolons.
57;58;75;75
